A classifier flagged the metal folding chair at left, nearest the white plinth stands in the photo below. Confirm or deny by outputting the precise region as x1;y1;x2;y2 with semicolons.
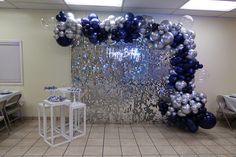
3;94;23;128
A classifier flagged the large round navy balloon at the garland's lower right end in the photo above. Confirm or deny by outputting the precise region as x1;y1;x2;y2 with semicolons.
199;112;216;129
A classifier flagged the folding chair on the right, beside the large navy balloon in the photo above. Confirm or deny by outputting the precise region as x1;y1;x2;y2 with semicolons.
216;95;236;129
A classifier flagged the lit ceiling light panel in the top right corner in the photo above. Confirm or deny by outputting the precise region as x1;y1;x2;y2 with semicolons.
180;0;236;11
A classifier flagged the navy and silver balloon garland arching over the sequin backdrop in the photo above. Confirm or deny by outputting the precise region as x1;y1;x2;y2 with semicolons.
54;11;216;132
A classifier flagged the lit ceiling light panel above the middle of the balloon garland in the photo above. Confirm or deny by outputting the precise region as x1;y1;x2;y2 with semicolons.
65;0;123;7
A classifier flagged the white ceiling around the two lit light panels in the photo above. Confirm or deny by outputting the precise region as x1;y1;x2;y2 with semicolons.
0;0;236;18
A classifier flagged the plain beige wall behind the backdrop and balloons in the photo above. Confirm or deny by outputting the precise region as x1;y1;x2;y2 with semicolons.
0;9;236;116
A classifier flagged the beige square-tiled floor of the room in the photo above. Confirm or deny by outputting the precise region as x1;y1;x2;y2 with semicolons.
0;121;236;157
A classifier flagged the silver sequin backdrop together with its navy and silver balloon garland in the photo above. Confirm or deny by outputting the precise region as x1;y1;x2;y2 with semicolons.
51;11;216;132
